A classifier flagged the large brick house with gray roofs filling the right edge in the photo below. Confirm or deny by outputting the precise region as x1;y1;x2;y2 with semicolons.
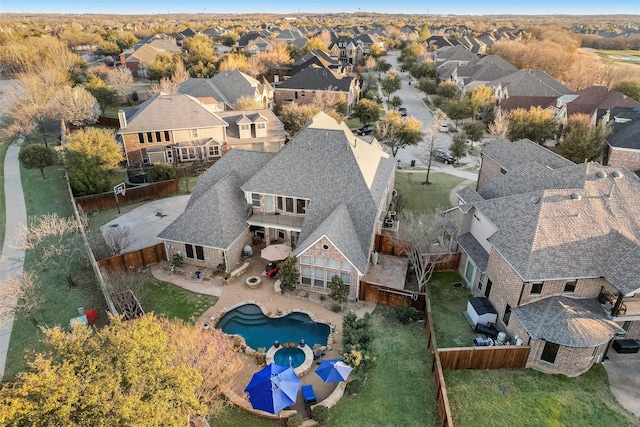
447;140;640;376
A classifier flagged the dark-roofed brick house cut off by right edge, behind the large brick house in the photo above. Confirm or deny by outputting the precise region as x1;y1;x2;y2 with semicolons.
602;105;640;174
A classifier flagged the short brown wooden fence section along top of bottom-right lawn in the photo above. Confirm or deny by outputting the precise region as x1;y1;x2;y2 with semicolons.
438;345;531;371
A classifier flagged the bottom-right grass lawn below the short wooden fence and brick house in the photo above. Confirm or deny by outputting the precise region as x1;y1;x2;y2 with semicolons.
444;365;637;427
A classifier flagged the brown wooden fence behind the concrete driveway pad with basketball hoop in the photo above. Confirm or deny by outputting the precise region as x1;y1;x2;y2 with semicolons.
74;179;178;212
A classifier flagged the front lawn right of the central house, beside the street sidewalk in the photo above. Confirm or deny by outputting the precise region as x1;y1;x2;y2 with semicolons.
395;171;464;212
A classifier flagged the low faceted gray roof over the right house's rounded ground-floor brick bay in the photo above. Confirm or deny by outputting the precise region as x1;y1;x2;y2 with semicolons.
512;296;623;348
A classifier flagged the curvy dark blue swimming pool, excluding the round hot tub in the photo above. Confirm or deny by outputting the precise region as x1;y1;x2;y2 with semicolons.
216;304;330;350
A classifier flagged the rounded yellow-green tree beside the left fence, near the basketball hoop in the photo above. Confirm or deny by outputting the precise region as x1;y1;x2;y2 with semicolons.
64;128;123;195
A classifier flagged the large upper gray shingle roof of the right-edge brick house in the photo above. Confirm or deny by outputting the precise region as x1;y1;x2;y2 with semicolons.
468;163;640;294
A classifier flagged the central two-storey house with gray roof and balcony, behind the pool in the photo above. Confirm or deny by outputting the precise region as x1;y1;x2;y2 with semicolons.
158;113;395;298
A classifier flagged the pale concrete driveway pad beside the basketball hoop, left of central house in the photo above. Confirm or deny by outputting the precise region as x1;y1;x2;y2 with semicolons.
100;195;190;252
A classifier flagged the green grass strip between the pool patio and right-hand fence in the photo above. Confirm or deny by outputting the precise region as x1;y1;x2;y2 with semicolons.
327;305;440;427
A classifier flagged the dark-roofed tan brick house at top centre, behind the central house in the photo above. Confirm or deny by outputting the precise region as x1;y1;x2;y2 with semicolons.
275;65;360;113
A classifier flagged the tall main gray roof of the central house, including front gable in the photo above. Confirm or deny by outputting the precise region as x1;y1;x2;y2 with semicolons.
242;113;395;273
